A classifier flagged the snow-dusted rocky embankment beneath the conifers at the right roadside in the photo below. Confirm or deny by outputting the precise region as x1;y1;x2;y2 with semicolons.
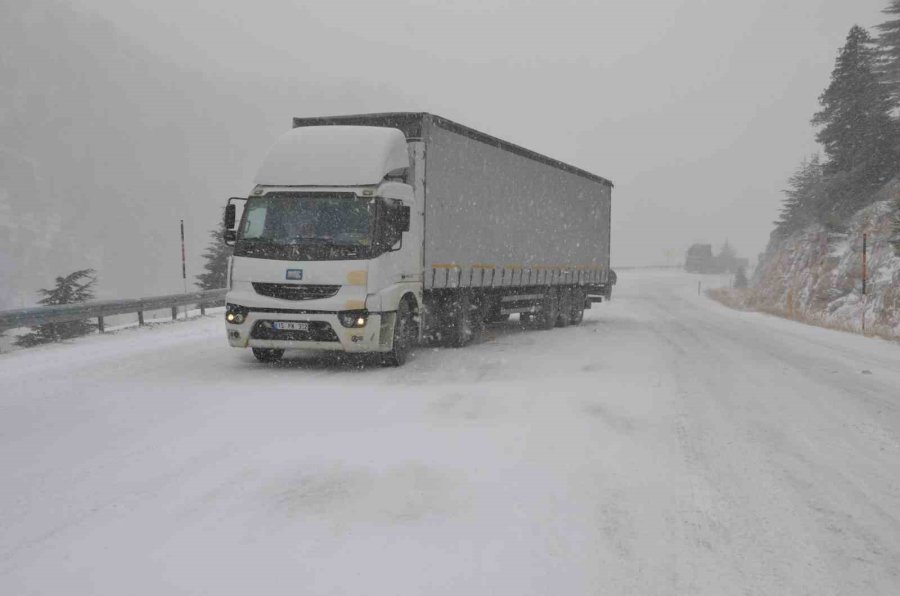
741;200;900;337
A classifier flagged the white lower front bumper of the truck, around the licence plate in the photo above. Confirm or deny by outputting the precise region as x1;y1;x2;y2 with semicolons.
225;309;394;353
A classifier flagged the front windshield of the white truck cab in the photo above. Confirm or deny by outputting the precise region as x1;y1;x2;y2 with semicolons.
240;193;374;247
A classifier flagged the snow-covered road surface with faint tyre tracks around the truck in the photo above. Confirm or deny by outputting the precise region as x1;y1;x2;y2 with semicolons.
0;271;900;596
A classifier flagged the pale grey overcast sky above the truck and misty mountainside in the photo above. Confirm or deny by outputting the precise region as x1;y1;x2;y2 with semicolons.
73;0;887;265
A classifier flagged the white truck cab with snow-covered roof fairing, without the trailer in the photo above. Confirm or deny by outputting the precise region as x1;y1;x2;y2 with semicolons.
225;126;423;365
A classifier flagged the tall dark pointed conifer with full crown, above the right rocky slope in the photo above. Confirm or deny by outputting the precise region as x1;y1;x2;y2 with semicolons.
812;26;898;217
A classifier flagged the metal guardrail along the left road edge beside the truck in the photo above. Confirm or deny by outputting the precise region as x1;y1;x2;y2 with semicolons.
0;288;225;333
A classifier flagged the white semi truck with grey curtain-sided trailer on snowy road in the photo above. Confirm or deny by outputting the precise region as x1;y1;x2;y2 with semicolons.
225;112;614;366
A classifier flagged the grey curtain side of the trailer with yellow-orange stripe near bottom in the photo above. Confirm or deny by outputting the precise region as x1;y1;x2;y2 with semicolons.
423;121;611;289
